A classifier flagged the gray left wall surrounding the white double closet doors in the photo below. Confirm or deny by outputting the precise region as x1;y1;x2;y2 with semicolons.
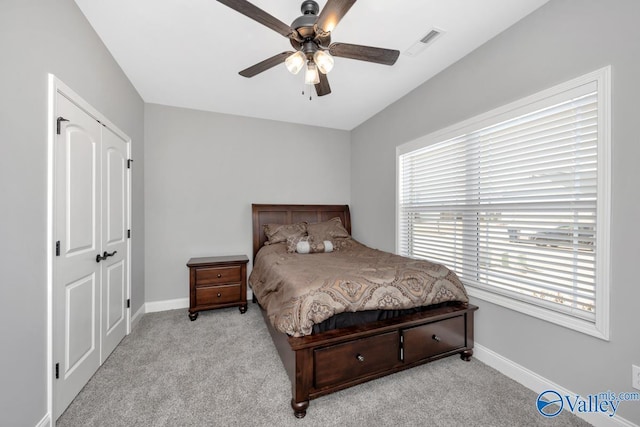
0;0;144;426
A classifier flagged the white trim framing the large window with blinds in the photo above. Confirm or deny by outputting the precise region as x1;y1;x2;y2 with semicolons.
396;66;611;341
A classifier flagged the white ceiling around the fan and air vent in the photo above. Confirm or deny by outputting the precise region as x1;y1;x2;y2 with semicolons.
75;0;548;130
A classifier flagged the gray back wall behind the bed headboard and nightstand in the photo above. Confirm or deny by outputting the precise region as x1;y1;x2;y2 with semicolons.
145;104;351;302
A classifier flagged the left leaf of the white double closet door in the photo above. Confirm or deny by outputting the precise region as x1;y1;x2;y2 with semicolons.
53;95;102;418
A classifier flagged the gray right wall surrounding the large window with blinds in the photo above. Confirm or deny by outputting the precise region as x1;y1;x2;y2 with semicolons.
351;0;640;423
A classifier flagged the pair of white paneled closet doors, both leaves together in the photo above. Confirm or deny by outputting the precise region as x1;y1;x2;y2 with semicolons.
53;88;129;419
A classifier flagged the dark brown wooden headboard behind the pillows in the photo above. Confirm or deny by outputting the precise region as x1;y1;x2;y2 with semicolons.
251;204;351;258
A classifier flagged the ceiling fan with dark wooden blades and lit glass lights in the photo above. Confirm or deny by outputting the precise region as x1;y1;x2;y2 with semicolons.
218;0;400;96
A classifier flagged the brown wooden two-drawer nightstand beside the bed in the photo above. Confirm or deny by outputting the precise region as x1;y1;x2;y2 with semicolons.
187;255;249;321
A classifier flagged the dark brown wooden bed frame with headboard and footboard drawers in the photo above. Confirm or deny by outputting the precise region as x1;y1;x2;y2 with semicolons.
252;204;478;418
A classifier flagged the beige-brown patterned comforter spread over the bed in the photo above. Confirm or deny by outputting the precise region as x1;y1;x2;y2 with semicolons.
249;240;468;337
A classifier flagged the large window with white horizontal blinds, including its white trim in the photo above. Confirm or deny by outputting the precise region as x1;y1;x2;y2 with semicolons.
397;68;610;339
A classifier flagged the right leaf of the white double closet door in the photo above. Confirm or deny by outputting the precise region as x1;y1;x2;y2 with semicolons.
100;128;129;361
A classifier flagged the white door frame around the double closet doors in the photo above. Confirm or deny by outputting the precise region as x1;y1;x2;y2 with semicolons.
47;74;131;425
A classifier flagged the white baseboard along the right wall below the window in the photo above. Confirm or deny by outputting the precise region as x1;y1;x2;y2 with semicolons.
473;342;638;427
